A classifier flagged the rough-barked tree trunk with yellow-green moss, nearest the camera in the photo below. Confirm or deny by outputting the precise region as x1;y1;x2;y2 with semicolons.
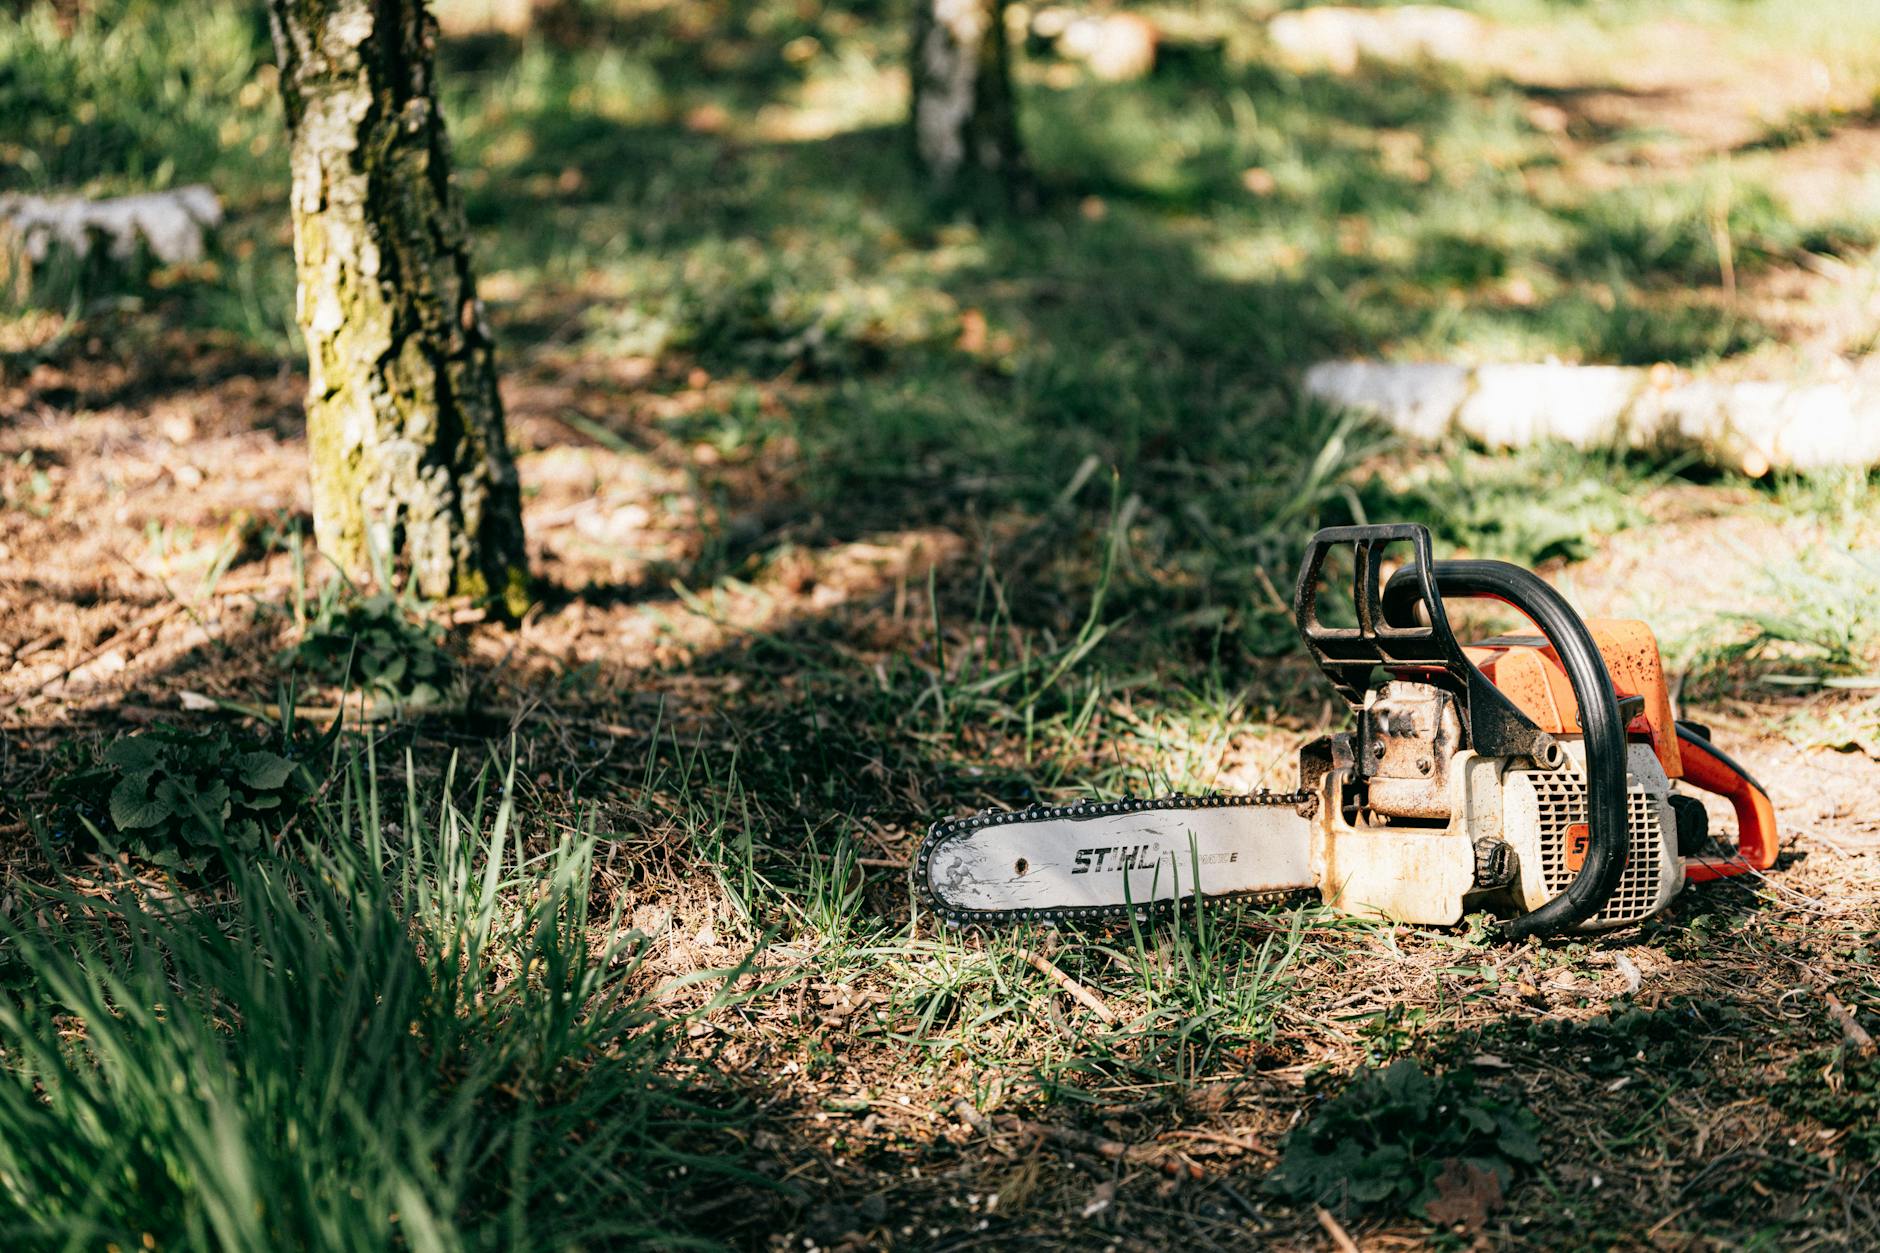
269;0;528;611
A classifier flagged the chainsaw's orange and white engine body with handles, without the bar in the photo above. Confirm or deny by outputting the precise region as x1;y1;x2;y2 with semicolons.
1293;525;1775;933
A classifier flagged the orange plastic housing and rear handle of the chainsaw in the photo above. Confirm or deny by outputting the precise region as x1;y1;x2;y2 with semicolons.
1463;619;1777;882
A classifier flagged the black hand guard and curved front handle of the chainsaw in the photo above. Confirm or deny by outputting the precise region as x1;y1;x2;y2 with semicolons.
1293;523;1632;939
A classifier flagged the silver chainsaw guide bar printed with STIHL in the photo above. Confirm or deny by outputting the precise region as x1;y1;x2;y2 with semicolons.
914;792;1318;926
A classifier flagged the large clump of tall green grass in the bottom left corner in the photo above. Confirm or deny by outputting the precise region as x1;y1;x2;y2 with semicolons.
0;745;763;1249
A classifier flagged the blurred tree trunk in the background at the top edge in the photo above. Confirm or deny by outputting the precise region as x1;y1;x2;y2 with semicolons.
912;0;1030;207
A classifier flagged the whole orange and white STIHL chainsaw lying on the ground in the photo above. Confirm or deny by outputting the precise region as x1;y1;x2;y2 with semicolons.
914;525;1777;939
